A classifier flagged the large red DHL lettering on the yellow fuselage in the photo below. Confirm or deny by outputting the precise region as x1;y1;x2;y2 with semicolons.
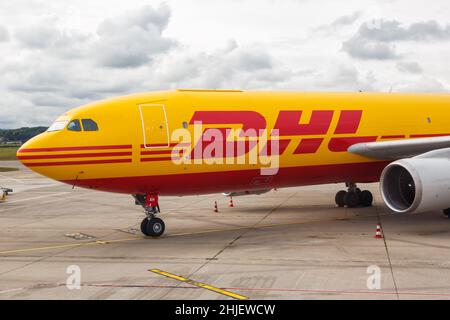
189;110;366;159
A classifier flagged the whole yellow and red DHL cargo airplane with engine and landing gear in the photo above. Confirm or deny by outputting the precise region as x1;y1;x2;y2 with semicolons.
17;90;450;236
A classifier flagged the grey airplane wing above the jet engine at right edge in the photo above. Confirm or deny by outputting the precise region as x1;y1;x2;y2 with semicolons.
347;136;450;160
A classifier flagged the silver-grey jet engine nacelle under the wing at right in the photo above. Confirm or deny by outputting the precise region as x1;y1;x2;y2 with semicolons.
380;157;450;213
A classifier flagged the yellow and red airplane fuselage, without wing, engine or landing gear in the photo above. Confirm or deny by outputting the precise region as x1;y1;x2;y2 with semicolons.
18;90;450;195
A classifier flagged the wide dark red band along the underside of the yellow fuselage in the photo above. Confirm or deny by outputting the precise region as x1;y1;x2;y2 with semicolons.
63;161;389;195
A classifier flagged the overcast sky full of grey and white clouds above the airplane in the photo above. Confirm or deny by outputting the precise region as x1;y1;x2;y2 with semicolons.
0;0;450;128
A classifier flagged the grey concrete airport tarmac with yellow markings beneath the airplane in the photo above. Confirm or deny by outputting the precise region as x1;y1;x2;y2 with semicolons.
0;161;450;300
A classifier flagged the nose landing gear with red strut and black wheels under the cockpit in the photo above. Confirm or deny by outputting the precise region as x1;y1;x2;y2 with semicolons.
133;194;166;237
